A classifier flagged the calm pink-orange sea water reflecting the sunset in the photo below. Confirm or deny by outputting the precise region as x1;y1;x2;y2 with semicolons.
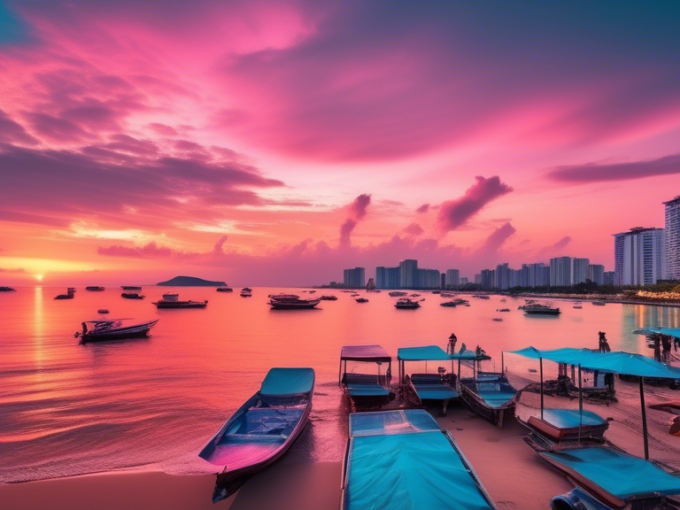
0;287;680;482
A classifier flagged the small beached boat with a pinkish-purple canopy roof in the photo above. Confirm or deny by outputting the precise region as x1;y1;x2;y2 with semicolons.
339;345;395;410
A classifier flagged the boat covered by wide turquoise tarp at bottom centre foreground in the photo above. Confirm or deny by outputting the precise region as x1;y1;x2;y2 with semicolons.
340;409;496;510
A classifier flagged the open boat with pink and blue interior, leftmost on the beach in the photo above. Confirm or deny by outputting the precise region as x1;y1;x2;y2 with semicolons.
198;368;314;502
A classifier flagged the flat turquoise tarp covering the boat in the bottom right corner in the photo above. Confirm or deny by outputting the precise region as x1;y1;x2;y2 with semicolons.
541;448;680;500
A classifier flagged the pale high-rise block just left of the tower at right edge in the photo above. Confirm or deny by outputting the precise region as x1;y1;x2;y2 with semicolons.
614;227;666;287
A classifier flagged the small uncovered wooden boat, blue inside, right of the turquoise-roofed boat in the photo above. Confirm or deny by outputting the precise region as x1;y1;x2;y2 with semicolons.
459;372;517;427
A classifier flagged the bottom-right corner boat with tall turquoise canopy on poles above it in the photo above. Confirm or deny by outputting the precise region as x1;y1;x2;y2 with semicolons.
510;347;680;510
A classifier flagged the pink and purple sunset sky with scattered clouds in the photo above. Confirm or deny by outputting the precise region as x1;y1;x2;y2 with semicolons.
0;0;680;286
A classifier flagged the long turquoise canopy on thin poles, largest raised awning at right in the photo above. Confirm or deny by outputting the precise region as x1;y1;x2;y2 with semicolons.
510;347;680;379
